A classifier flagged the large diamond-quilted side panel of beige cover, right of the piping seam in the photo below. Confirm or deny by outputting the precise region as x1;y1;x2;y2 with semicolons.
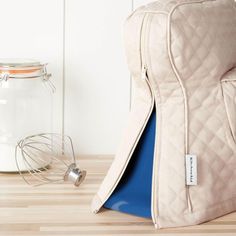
171;0;236;210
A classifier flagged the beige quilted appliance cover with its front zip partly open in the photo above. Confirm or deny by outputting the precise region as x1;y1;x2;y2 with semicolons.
92;0;236;228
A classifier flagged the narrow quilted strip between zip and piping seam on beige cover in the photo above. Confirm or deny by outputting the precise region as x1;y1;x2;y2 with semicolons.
147;12;191;218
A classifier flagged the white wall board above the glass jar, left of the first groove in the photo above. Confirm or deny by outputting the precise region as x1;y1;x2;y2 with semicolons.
0;0;63;132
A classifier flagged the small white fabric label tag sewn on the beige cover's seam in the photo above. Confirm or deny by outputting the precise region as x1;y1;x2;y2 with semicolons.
185;154;197;185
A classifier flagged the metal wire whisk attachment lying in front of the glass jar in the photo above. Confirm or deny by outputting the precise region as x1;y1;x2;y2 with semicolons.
15;133;86;186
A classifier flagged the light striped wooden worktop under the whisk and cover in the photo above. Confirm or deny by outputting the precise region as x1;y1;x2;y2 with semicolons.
0;156;236;236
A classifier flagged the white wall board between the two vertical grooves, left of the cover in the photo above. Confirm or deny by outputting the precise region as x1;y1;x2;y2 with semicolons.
65;0;131;154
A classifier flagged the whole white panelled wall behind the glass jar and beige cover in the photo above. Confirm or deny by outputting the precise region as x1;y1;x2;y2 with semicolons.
0;0;148;154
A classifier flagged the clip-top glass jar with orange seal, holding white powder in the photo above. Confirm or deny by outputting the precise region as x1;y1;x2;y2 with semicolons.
0;59;54;172
